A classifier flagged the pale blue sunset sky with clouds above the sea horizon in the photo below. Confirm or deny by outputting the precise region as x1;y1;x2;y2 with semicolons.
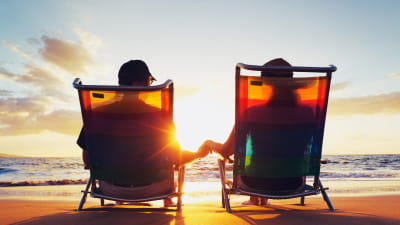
0;0;400;157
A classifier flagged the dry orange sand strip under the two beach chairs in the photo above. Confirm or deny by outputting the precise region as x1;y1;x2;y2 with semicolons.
0;195;400;225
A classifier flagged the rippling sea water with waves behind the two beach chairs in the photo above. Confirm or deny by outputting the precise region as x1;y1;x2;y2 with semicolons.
0;154;400;186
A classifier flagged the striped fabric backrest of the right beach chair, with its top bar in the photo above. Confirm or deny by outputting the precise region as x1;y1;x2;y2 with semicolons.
234;64;336;185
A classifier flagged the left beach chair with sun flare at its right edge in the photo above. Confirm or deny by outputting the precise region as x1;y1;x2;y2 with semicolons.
73;78;185;211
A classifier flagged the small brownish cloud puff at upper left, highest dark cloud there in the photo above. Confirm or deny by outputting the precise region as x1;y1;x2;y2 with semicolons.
38;35;94;74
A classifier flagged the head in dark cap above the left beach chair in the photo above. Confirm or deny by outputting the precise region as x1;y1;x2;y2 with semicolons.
118;60;156;86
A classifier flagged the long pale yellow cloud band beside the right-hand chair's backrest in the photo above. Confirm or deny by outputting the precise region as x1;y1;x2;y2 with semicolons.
328;92;400;116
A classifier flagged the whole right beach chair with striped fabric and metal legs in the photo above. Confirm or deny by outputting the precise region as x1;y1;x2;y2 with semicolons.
218;63;336;212
